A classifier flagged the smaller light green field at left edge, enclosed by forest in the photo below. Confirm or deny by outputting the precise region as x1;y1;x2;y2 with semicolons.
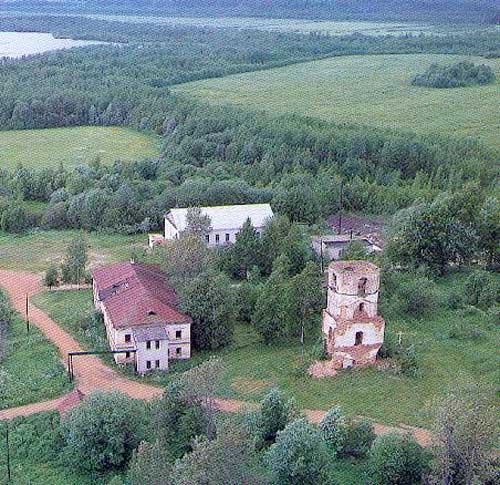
0;126;159;168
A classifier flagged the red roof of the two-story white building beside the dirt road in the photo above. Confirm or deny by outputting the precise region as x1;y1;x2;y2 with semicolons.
92;262;192;328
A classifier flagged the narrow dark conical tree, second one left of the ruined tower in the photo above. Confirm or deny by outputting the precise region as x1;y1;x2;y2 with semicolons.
252;256;290;344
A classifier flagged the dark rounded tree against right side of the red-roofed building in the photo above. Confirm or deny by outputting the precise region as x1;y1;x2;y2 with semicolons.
180;273;237;350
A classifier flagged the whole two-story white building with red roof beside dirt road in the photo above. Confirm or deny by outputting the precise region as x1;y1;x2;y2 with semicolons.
92;262;192;374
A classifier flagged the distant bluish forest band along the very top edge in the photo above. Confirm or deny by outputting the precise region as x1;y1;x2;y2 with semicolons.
5;0;499;23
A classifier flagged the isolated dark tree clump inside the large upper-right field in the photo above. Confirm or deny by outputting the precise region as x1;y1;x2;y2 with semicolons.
411;61;495;88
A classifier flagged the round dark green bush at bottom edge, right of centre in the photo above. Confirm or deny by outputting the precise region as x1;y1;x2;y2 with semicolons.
368;432;427;485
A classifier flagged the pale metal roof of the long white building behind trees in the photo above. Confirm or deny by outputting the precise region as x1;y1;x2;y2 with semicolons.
166;204;273;232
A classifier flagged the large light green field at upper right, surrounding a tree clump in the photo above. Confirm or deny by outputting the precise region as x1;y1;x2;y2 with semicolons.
175;54;500;147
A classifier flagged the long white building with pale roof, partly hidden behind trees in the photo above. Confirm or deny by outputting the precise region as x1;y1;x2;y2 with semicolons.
163;204;273;247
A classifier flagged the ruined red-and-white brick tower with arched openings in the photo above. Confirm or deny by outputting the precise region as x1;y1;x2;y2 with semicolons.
323;261;385;369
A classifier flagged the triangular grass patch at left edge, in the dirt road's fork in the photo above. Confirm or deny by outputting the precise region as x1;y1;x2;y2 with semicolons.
0;310;72;408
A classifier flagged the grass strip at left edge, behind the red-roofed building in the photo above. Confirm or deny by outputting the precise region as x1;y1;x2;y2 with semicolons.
0;231;147;272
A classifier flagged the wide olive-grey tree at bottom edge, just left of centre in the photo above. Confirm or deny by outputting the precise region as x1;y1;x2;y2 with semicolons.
170;425;262;485
